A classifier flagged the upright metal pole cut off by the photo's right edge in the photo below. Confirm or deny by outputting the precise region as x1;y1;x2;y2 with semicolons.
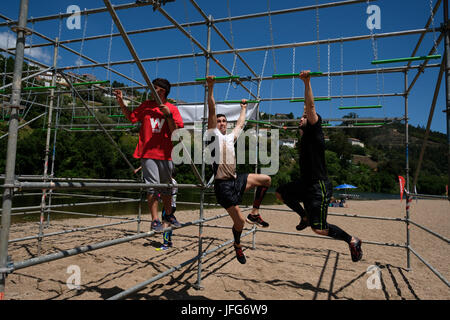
443;0;450;200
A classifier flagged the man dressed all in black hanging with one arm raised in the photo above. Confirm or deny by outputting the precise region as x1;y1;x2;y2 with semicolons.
276;71;362;262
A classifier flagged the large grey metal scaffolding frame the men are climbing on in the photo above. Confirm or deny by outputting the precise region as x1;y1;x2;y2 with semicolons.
0;0;450;300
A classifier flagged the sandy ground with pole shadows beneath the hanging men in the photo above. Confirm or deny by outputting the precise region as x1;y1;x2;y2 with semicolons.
5;200;450;300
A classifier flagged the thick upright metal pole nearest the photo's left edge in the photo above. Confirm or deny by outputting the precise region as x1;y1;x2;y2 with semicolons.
0;0;28;300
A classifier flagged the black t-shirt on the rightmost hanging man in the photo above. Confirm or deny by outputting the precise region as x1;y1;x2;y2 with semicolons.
299;115;328;181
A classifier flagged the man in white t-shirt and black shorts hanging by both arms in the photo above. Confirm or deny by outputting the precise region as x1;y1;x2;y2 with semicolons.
206;76;271;264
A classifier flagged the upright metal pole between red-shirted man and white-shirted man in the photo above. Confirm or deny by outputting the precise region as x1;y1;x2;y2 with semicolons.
194;15;212;290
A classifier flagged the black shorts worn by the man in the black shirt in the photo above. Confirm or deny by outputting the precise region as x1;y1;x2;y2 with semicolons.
276;180;333;230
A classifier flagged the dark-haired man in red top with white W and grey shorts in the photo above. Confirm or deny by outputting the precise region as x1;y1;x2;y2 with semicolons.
114;78;183;231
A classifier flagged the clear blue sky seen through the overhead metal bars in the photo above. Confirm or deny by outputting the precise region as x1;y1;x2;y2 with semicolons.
0;0;446;133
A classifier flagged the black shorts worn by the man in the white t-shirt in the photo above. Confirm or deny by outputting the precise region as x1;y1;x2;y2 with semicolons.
214;173;248;209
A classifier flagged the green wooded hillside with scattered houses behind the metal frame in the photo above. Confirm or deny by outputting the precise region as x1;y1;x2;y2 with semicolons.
0;57;448;194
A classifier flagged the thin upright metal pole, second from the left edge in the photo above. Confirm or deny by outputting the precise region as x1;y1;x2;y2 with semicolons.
37;38;59;256
